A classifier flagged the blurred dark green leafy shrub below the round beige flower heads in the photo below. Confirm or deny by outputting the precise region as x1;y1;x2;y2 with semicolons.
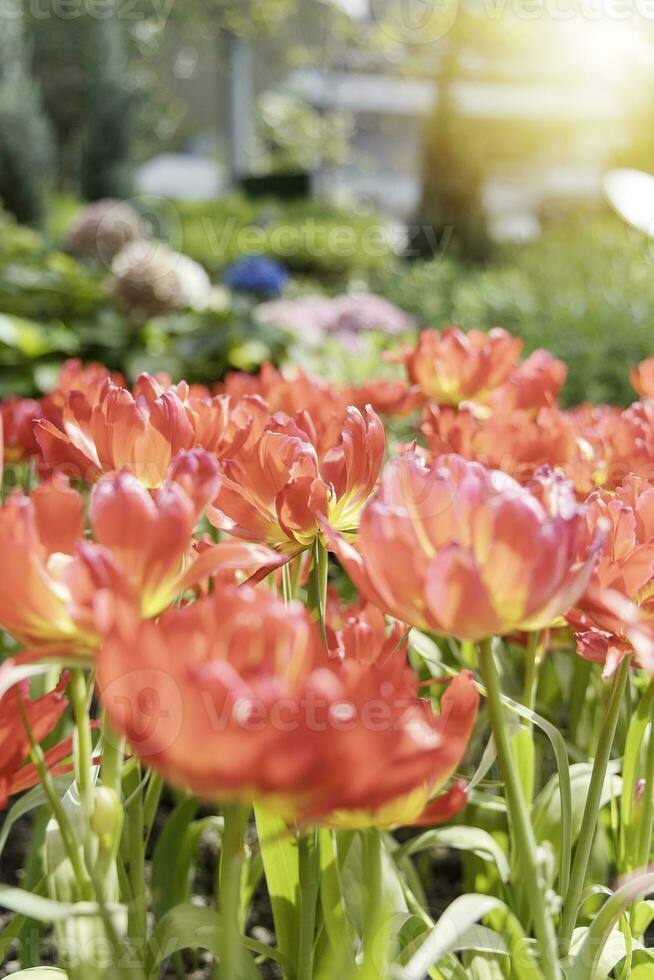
0;212;288;396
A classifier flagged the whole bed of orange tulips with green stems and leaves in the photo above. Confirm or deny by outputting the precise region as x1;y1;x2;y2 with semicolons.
0;324;654;980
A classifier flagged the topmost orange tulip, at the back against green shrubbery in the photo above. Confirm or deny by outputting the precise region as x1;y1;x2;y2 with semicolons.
403;327;522;405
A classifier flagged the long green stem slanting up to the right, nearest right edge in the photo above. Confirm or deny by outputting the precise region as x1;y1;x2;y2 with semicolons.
560;657;631;954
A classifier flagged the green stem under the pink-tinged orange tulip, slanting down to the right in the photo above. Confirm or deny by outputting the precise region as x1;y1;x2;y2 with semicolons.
479;640;561;980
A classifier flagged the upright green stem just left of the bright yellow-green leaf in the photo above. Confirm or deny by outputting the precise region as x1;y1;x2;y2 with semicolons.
222;803;248;980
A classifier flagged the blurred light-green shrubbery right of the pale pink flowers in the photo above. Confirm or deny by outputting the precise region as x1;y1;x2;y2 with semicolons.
384;216;654;404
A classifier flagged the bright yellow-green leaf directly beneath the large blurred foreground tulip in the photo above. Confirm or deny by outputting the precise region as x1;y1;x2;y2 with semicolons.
254;806;300;962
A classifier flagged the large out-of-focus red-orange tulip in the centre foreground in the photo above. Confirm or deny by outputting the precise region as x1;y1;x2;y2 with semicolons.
98;585;478;826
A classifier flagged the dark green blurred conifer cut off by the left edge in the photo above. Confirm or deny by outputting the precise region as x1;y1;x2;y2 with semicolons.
0;0;51;224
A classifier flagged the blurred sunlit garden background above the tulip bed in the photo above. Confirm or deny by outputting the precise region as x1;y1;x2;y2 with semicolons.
0;0;654;404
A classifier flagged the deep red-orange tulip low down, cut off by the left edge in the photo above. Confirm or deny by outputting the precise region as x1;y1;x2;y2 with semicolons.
0;662;72;810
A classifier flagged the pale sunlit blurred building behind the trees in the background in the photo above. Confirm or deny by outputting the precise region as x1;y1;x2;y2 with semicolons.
137;0;649;237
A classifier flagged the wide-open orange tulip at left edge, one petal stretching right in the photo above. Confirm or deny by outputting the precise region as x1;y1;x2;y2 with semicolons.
0;449;281;658
